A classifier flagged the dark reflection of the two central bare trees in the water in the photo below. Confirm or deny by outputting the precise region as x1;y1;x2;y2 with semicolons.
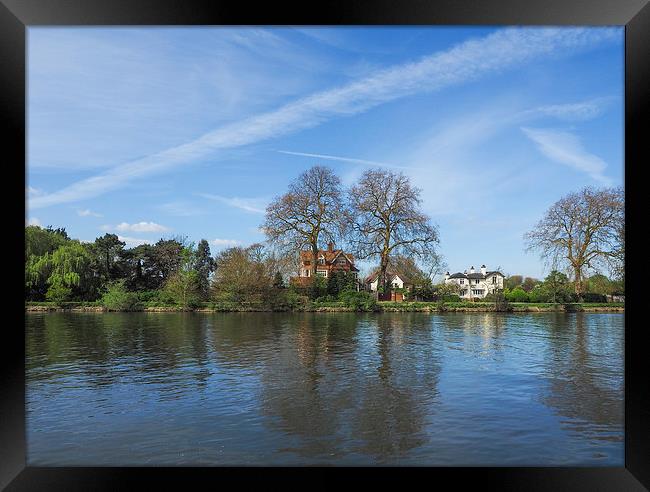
254;314;440;461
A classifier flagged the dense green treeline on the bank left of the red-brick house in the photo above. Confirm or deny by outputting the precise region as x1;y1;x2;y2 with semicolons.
25;226;374;311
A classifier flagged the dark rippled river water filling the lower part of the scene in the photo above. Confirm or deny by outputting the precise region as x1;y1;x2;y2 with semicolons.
26;313;624;466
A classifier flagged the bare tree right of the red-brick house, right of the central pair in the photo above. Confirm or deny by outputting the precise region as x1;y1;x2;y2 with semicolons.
349;169;438;298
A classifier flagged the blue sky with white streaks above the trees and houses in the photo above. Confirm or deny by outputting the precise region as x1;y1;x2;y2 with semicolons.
26;27;624;277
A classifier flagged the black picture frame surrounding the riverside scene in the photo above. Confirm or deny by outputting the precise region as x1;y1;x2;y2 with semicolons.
0;0;650;491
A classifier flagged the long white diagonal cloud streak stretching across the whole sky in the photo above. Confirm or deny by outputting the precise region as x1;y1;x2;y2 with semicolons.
30;27;620;209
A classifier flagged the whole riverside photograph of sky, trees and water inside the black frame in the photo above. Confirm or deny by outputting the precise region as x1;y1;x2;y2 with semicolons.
18;24;624;468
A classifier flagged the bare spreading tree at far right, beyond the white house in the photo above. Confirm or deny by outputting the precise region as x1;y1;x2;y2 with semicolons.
524;187;625;296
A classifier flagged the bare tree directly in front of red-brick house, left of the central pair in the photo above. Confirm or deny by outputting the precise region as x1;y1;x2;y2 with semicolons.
263;166;345;277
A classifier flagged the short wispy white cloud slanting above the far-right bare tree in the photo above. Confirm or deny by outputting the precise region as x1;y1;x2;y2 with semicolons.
522;127;612;185
